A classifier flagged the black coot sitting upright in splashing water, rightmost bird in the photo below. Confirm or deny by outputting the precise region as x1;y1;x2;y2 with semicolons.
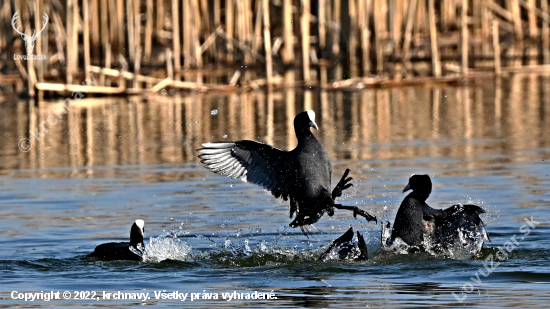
381;175;491;255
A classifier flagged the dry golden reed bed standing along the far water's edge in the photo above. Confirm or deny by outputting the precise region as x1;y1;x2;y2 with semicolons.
0;0;550;98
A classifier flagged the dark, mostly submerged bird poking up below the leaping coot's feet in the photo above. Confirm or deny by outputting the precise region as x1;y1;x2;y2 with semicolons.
319;227;369;261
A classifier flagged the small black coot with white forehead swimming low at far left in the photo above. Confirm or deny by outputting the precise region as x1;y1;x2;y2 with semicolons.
88;219;145;261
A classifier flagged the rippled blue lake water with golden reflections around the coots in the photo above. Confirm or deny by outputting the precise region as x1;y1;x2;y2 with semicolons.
0;75;550;308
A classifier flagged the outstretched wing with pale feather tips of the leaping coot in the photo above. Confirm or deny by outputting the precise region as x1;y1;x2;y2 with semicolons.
197;141;296;200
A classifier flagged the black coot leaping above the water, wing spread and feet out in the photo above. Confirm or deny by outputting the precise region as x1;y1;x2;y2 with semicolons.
197;110;376;236
